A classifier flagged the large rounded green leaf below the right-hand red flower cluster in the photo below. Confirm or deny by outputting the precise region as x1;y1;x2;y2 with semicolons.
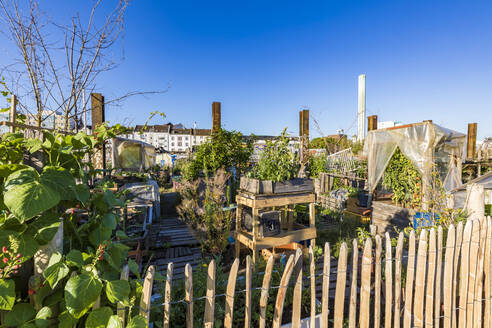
65;272;102;318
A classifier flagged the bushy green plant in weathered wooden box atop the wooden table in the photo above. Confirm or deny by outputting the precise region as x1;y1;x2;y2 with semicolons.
239;129;314;194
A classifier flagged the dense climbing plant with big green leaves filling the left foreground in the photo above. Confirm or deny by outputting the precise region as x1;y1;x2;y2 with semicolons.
0;126;146;327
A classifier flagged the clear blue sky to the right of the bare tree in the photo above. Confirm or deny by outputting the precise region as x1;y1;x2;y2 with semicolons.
0;0;492;139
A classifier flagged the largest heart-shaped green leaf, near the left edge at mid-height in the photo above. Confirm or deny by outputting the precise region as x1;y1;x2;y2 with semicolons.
4;169;60;222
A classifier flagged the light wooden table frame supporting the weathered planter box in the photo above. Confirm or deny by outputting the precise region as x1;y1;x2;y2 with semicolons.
235;190;316;263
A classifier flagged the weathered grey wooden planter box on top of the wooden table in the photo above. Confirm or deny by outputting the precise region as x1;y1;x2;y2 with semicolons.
239;177;314;194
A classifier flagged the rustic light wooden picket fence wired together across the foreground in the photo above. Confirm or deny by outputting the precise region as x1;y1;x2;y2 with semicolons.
129;217;492;328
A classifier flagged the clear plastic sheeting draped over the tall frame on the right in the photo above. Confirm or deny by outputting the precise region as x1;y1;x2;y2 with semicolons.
364;122;466;192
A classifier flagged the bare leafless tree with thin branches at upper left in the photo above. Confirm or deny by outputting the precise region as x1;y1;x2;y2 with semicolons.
0;0;165;130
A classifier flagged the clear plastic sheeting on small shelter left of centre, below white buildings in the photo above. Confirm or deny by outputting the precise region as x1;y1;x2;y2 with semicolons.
112;138;155;170
